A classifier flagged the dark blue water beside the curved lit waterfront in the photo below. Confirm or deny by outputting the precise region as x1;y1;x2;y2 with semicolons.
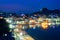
26;26;60;40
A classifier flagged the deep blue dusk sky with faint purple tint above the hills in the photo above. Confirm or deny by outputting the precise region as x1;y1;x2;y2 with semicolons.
0;0;60;12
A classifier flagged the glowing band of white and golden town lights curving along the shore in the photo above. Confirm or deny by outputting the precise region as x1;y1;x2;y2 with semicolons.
2;13;60;40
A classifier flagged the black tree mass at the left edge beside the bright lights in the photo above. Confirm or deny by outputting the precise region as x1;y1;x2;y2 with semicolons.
0;19;10;35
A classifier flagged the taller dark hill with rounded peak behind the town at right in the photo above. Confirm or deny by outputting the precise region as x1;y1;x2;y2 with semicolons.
33;8;60;16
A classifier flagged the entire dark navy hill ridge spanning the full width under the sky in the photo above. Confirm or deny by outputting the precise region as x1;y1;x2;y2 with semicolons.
0;8;60;17
